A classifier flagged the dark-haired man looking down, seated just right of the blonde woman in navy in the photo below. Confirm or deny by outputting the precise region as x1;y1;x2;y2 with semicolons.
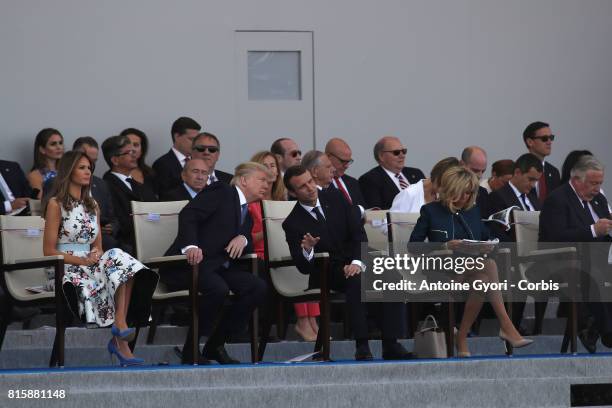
487;153;546;334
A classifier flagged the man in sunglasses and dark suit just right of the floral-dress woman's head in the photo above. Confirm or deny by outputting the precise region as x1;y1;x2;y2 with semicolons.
102;136;157;255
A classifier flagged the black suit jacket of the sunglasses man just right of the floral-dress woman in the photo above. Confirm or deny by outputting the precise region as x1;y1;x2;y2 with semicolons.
103;171;157;252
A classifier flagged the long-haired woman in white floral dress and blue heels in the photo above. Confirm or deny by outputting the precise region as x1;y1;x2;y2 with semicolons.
43;150;157;366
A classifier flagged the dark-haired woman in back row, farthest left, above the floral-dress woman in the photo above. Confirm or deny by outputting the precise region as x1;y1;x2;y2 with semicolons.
28;128;64;199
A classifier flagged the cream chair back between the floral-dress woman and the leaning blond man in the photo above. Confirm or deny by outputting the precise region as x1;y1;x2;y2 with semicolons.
132;200;188;263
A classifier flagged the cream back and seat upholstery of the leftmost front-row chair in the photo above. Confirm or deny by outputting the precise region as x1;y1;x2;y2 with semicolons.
0;215;54;301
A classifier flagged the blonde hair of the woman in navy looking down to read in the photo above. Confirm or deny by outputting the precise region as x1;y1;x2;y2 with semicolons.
438;166;480;212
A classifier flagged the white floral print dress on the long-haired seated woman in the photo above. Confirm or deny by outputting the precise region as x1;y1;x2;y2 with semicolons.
57;203;146;326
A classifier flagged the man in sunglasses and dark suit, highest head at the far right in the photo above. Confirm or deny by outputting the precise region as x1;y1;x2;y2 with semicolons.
523;122;561;203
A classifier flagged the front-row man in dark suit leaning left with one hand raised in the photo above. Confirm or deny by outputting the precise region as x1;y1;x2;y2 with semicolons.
283;166;411;360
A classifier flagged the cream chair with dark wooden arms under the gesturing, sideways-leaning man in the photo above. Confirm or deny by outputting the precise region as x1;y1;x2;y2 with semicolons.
259;200;330;360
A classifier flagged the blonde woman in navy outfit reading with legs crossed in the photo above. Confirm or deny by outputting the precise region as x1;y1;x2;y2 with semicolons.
410;167;533;357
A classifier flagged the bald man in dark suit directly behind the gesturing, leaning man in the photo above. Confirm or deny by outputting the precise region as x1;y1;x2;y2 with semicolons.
325;137;366;212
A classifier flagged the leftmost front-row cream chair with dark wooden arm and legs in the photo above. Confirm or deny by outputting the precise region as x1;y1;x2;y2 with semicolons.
0;215;65;367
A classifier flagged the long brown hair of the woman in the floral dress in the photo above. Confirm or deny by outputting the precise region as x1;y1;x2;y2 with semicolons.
43;150;98;214
